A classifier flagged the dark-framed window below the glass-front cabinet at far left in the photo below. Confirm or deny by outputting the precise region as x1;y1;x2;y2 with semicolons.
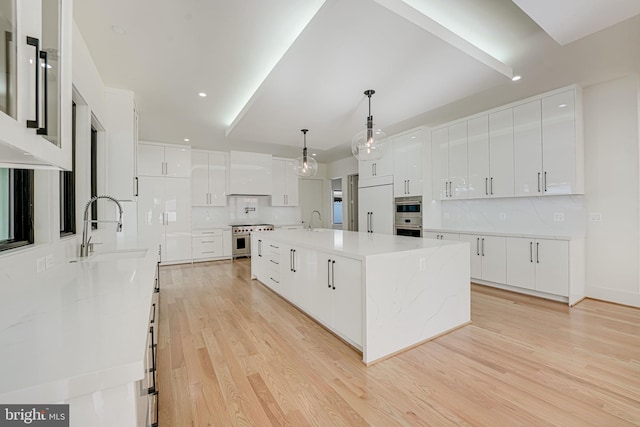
0;169;33;251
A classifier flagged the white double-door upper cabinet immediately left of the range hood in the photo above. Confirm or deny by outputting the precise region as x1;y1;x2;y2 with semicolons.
191;150;227;206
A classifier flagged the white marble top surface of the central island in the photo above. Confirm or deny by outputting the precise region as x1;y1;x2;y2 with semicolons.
251;228;461;259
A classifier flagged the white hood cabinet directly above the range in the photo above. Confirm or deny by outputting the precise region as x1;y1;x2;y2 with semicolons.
227;151;273;195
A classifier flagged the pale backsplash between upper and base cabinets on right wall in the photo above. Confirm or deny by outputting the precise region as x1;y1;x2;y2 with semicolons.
441;196;587;237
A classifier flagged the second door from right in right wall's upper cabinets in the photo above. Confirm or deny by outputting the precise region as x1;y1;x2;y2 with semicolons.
513;100;542;196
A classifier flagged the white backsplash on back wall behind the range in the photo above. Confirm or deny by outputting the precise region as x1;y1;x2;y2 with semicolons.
191;196;301;229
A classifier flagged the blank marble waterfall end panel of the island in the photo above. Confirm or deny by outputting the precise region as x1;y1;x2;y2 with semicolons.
363;242;471;364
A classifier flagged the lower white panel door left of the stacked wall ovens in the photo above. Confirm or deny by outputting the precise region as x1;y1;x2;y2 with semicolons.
358;185;393;234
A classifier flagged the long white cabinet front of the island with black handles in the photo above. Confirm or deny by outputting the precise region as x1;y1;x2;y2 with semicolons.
251;237;364;347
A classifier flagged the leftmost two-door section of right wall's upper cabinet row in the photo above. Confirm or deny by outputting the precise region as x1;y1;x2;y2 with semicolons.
431;121;468;200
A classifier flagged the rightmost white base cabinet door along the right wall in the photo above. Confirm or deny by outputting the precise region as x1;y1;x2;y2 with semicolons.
535;239;569;296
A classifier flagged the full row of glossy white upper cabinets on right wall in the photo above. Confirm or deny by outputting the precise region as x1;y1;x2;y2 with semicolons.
432;87;584;200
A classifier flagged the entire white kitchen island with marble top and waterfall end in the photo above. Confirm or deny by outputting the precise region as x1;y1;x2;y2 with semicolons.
251;229;471;364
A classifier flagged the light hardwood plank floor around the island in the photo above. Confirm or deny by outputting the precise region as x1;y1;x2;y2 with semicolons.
158;260;640;427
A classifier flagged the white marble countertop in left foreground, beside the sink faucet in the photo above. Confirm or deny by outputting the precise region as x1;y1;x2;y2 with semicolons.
0;249;157;403
